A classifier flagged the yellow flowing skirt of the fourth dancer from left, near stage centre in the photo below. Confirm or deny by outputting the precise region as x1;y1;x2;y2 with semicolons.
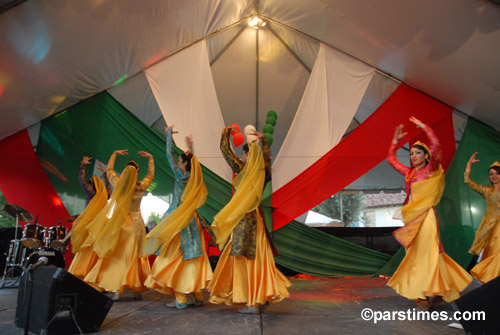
208;215;291;306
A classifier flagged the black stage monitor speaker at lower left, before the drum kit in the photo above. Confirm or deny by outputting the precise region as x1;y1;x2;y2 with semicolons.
15;266;113;335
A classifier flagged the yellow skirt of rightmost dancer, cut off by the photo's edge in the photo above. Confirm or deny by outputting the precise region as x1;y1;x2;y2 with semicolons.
471;224;500;283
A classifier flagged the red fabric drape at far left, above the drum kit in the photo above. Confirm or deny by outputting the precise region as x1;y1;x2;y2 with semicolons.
0;130;71;266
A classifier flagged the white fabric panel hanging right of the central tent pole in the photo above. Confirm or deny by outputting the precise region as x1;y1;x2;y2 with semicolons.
273;44;375;190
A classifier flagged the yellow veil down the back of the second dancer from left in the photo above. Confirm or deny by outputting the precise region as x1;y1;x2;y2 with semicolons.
82;165;137;258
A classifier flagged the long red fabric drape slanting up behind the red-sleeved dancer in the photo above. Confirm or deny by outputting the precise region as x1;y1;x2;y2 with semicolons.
272;84;455;230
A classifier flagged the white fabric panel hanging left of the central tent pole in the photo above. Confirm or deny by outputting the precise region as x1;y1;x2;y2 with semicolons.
146;41;231;181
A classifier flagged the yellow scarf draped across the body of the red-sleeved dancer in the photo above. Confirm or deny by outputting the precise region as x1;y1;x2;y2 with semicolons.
393;165;444;248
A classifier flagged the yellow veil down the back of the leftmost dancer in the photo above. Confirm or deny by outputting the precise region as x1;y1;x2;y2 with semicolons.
71;176;108;253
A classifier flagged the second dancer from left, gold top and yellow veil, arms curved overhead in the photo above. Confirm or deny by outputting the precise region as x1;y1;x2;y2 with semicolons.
84;149;154;300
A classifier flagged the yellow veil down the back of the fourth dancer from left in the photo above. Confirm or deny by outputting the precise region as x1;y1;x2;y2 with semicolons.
211;143;266;249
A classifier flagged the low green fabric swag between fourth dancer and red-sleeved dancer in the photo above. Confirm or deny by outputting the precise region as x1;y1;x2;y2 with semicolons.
274;221;392;276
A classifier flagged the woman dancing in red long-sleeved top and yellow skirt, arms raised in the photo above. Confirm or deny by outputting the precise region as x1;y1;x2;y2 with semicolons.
387;117;472;307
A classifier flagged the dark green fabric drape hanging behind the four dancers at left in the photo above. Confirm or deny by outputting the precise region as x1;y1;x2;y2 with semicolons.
37;92;231;220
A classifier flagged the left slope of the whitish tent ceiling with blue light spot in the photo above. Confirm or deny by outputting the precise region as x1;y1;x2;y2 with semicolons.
0;0;255;139
